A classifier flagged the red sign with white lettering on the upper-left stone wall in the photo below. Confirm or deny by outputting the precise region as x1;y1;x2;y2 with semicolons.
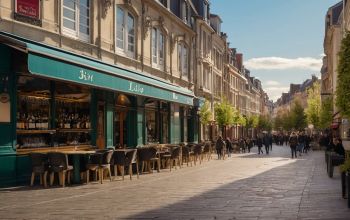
14;0;41;26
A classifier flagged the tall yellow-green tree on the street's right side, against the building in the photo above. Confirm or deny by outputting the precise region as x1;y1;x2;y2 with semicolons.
305;82;321;128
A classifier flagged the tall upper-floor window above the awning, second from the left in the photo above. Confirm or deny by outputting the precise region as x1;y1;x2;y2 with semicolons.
116;7;135;58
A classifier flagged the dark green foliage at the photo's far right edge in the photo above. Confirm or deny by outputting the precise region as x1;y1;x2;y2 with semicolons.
336;32;350;118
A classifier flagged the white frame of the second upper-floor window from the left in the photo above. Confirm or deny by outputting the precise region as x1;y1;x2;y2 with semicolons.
114;5;137;59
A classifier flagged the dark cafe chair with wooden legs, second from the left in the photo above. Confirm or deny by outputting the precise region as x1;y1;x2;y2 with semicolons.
47;152;73;187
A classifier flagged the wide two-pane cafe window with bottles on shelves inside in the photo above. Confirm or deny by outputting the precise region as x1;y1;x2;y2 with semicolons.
16;74;91;149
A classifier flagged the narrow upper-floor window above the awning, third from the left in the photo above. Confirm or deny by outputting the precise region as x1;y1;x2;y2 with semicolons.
151;28;164;68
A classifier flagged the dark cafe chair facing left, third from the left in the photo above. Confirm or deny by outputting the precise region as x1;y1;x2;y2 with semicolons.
86;149;113;184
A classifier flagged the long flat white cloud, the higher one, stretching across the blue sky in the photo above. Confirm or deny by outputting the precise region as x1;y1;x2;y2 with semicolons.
244;57;322;71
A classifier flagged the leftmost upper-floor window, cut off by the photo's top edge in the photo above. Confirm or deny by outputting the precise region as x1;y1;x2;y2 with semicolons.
63;0;90;41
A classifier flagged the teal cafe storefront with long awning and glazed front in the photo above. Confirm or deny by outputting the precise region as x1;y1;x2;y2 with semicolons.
0;32;198;186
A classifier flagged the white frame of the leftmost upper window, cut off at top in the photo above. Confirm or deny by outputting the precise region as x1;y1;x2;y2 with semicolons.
61;0;92;42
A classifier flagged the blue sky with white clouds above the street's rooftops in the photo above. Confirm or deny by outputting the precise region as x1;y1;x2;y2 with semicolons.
210;0;340;101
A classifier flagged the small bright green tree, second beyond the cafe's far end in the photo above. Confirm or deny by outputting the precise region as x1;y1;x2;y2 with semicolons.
214;98;235;134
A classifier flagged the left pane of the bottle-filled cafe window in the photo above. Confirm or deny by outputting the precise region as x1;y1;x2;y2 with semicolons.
16;75;55;148
